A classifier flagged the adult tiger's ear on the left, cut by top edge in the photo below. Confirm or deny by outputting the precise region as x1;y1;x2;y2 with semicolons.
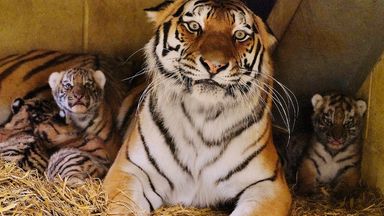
144;0;184;27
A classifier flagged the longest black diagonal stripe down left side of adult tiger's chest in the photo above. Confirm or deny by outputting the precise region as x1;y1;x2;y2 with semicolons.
149;95;192;176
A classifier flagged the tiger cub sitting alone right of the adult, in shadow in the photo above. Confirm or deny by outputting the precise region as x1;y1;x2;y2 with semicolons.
298;94;367;197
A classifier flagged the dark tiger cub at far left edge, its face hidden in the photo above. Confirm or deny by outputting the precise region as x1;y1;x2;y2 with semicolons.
0;98;58;173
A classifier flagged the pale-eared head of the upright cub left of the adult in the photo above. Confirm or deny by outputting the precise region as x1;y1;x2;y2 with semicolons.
49;68;106;114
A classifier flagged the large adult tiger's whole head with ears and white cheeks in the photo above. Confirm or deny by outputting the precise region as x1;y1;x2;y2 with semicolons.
146;0;275;104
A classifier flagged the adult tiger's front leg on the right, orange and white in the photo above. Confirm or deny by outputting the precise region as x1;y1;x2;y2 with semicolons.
230;169;292;216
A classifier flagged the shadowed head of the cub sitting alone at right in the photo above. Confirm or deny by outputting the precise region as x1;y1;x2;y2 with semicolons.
312;94;367;151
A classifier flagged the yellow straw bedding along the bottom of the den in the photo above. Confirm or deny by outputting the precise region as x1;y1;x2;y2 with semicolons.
0;161;384;216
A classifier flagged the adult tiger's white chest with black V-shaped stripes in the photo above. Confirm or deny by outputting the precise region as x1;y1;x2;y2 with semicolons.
129;93;273;206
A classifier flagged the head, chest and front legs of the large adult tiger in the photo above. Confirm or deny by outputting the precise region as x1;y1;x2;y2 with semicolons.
104;0;291;216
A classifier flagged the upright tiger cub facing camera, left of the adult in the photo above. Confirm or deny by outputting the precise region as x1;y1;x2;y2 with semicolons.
36;68;119;184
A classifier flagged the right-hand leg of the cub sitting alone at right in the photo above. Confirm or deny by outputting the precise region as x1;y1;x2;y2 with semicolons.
332;167;360;198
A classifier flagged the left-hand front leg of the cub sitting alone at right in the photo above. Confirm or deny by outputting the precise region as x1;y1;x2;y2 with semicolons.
297;158;318;195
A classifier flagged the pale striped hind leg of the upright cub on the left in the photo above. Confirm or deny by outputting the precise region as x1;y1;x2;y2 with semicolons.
47;148;109;186
